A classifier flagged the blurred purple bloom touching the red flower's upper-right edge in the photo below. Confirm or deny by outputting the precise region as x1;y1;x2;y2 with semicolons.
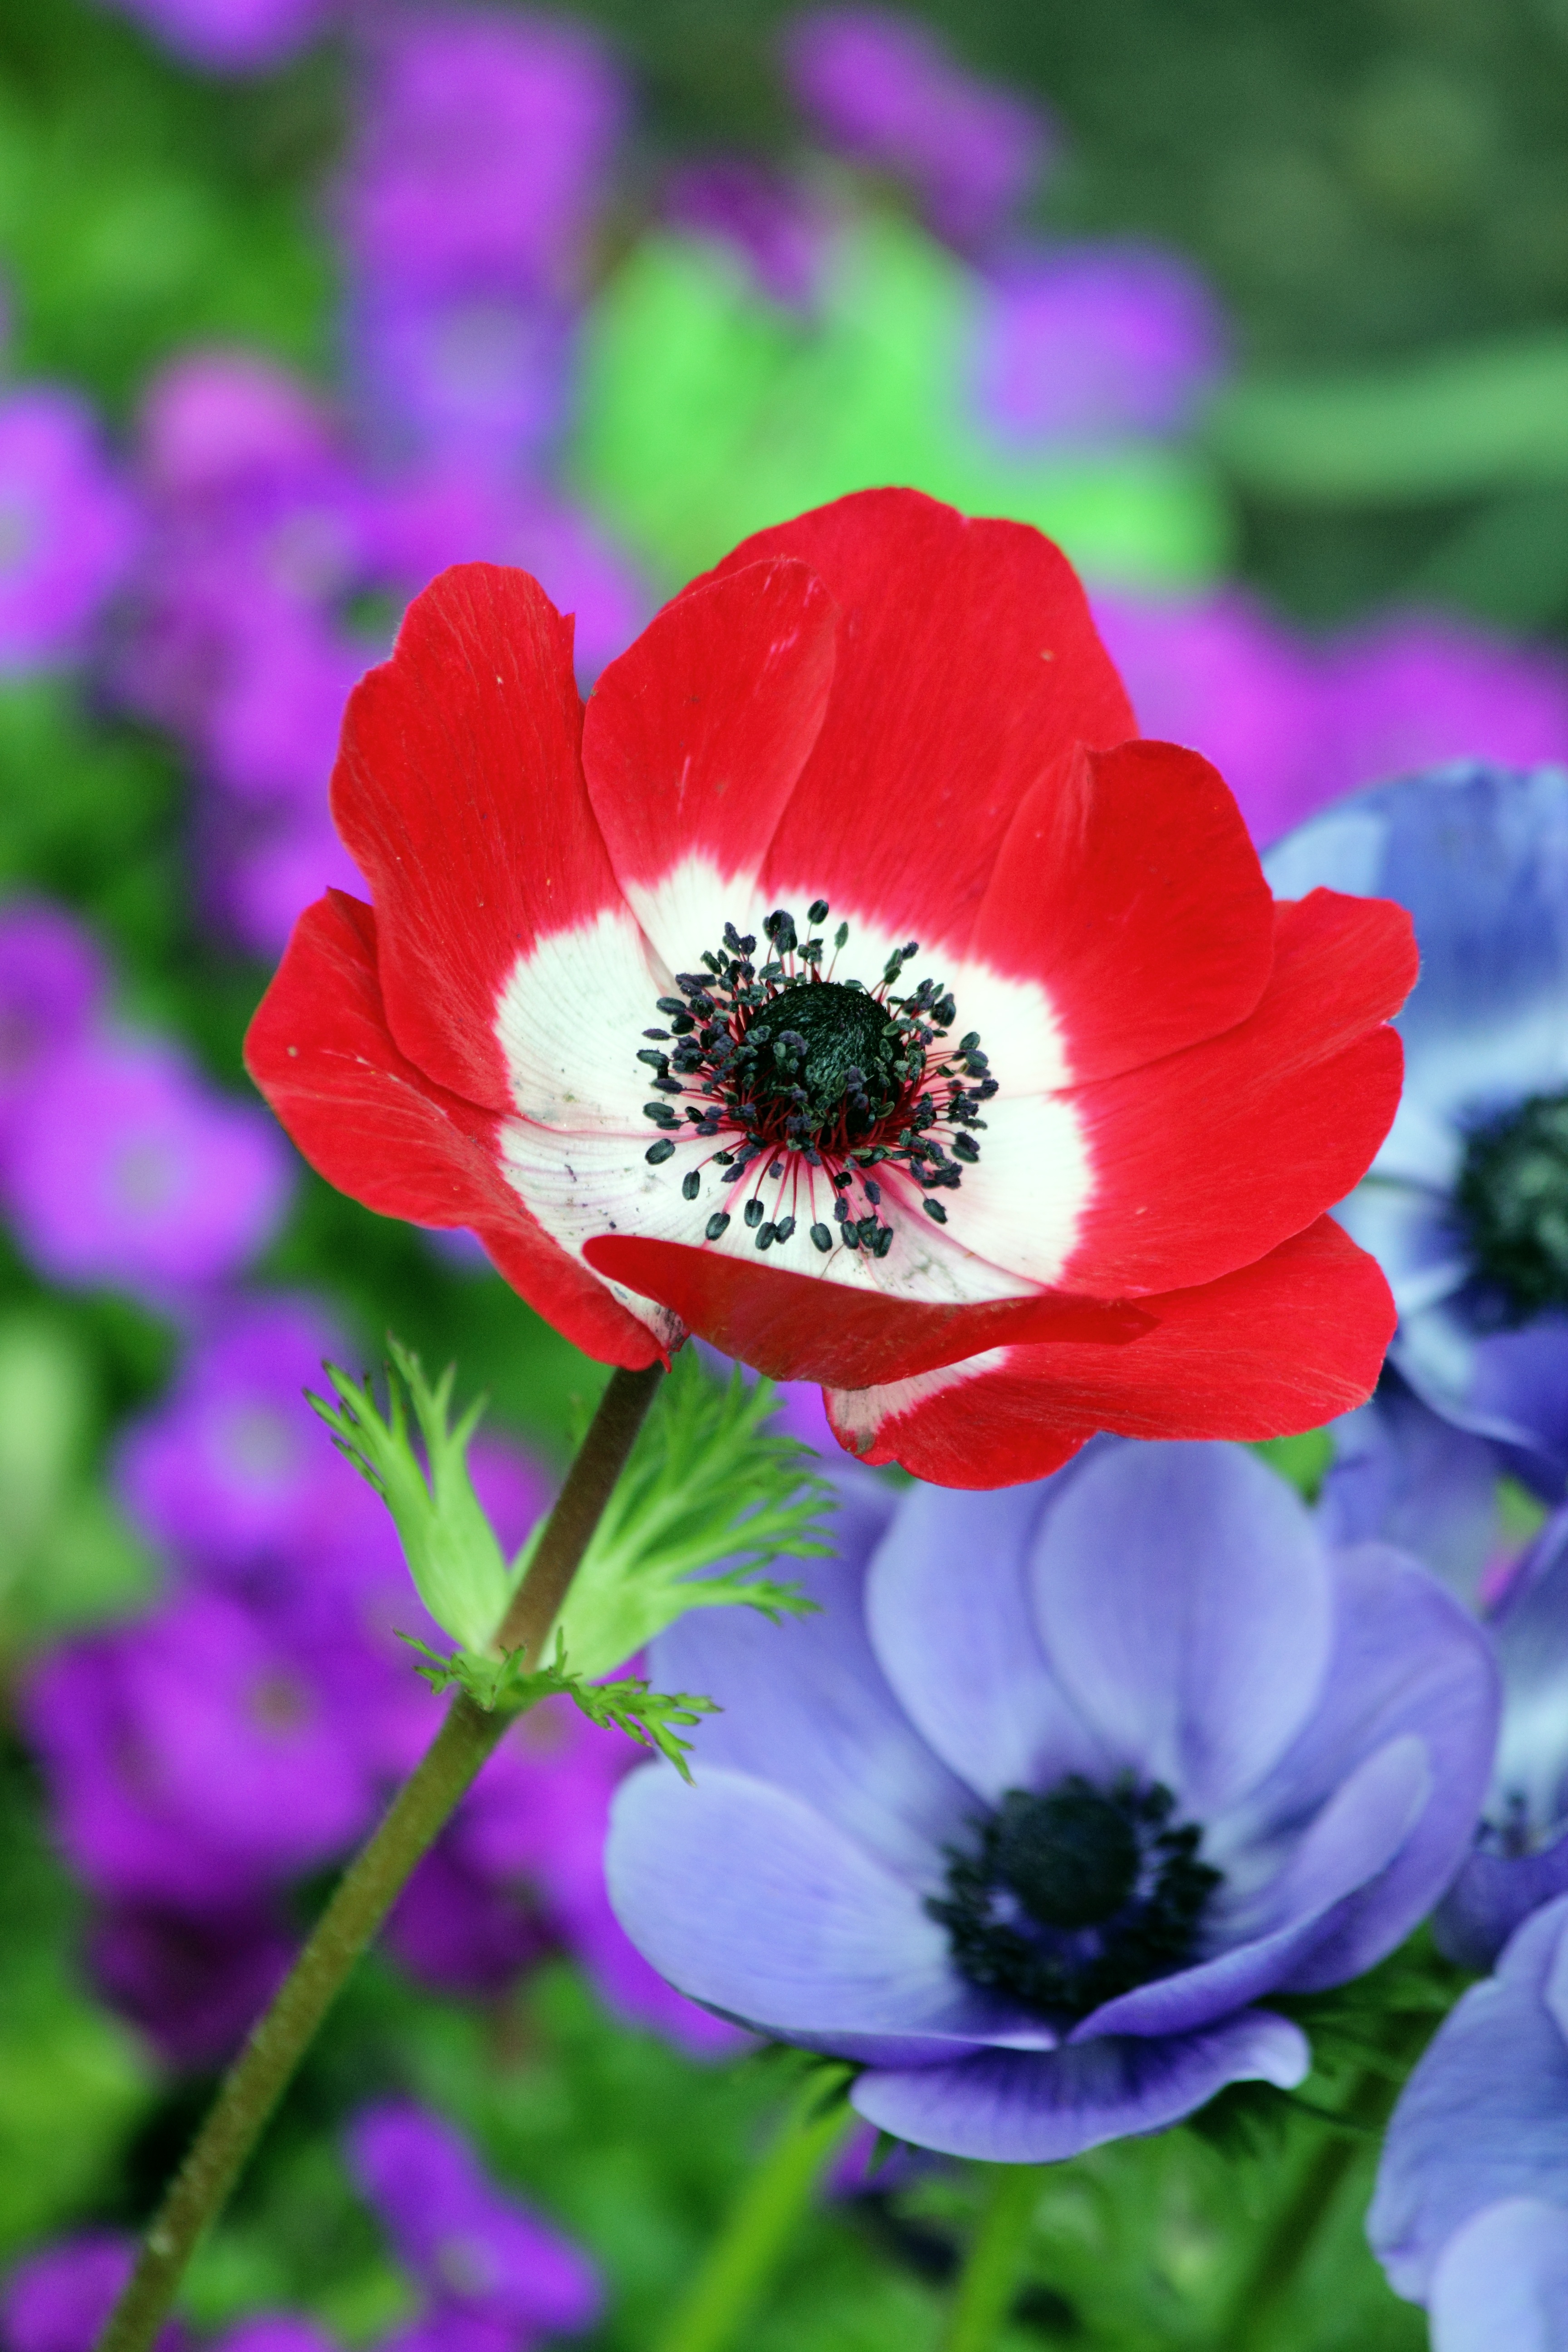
1096;588;1326;842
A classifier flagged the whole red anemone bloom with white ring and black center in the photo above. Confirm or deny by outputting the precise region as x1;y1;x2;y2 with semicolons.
249;489;1415;1486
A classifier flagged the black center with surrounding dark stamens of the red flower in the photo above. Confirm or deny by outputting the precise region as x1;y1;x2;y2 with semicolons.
637;898;997;1256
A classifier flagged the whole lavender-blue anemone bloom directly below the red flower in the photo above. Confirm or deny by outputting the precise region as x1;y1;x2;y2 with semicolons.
607;1444;1498;2164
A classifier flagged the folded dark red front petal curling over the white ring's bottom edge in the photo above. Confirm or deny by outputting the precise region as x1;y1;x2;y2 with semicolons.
583;1232;1161;1388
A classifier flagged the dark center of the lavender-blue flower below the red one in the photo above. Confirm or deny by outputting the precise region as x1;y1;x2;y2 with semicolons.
926;1774;1222;2020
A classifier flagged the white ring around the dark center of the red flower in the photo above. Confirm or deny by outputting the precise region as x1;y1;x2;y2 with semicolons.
496;856;1093;1305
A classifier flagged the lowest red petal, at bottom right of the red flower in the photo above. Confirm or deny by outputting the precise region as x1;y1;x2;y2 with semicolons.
828;1216;1394;1486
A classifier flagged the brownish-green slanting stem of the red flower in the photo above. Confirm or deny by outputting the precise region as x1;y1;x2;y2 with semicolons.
99;1364;661;2352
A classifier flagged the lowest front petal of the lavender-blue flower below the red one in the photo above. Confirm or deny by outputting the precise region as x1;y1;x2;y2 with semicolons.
848;2009;1312;2164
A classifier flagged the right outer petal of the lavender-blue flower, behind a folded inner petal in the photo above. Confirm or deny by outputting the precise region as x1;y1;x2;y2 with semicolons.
1230;1545;1500;1992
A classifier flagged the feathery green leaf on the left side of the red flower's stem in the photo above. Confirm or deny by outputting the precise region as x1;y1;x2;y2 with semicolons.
310;1338;515;1651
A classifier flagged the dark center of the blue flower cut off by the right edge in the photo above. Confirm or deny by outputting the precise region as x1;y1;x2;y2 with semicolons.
1453;1094;1568;1322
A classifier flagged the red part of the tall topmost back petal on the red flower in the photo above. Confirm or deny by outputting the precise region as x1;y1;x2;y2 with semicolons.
717;489;1138;948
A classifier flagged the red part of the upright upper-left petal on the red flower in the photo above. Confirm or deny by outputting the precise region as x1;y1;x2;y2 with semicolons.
332;564;621;1110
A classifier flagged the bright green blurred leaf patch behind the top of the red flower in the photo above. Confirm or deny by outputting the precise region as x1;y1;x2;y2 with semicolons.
571;214;1230;588
